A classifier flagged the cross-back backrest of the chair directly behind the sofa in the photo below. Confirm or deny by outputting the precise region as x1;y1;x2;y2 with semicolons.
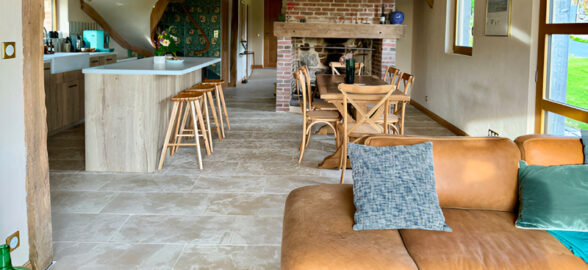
339;83;396;136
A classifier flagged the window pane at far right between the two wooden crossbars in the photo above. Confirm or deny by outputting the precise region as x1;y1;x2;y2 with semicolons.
546;34;588;109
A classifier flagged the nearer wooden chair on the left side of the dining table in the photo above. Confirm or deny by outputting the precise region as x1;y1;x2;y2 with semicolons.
294;69;341;164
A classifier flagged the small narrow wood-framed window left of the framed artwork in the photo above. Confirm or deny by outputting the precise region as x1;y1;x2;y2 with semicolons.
453;0;474;55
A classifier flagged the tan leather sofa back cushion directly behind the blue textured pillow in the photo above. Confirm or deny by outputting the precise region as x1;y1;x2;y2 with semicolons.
366;136;521;212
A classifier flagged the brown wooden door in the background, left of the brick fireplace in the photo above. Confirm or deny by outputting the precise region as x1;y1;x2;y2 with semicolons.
263;0;282;68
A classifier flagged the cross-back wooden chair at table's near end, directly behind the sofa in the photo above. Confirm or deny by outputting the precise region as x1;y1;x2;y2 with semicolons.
338;84;396;183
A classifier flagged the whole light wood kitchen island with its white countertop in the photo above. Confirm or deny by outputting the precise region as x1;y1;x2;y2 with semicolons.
83;57;220;172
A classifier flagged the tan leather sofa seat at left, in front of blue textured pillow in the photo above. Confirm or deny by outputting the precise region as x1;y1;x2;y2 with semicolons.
281;184;417;270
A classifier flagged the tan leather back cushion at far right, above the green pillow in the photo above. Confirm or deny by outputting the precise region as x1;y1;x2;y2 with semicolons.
515;135;584;166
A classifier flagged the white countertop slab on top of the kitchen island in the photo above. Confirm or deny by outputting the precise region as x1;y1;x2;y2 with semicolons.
82;57;221;75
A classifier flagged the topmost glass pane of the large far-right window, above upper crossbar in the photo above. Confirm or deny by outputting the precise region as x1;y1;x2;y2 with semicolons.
548;0;588;23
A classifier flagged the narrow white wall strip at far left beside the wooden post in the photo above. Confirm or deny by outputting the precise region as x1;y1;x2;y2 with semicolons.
0;0;30;265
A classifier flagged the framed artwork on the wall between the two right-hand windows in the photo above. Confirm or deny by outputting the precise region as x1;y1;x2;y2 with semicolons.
486;0;511;37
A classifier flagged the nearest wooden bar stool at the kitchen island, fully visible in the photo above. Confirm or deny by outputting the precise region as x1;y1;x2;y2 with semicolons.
159;91;211;170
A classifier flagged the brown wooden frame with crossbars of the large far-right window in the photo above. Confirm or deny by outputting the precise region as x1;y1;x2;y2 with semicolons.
535;0;588;134
